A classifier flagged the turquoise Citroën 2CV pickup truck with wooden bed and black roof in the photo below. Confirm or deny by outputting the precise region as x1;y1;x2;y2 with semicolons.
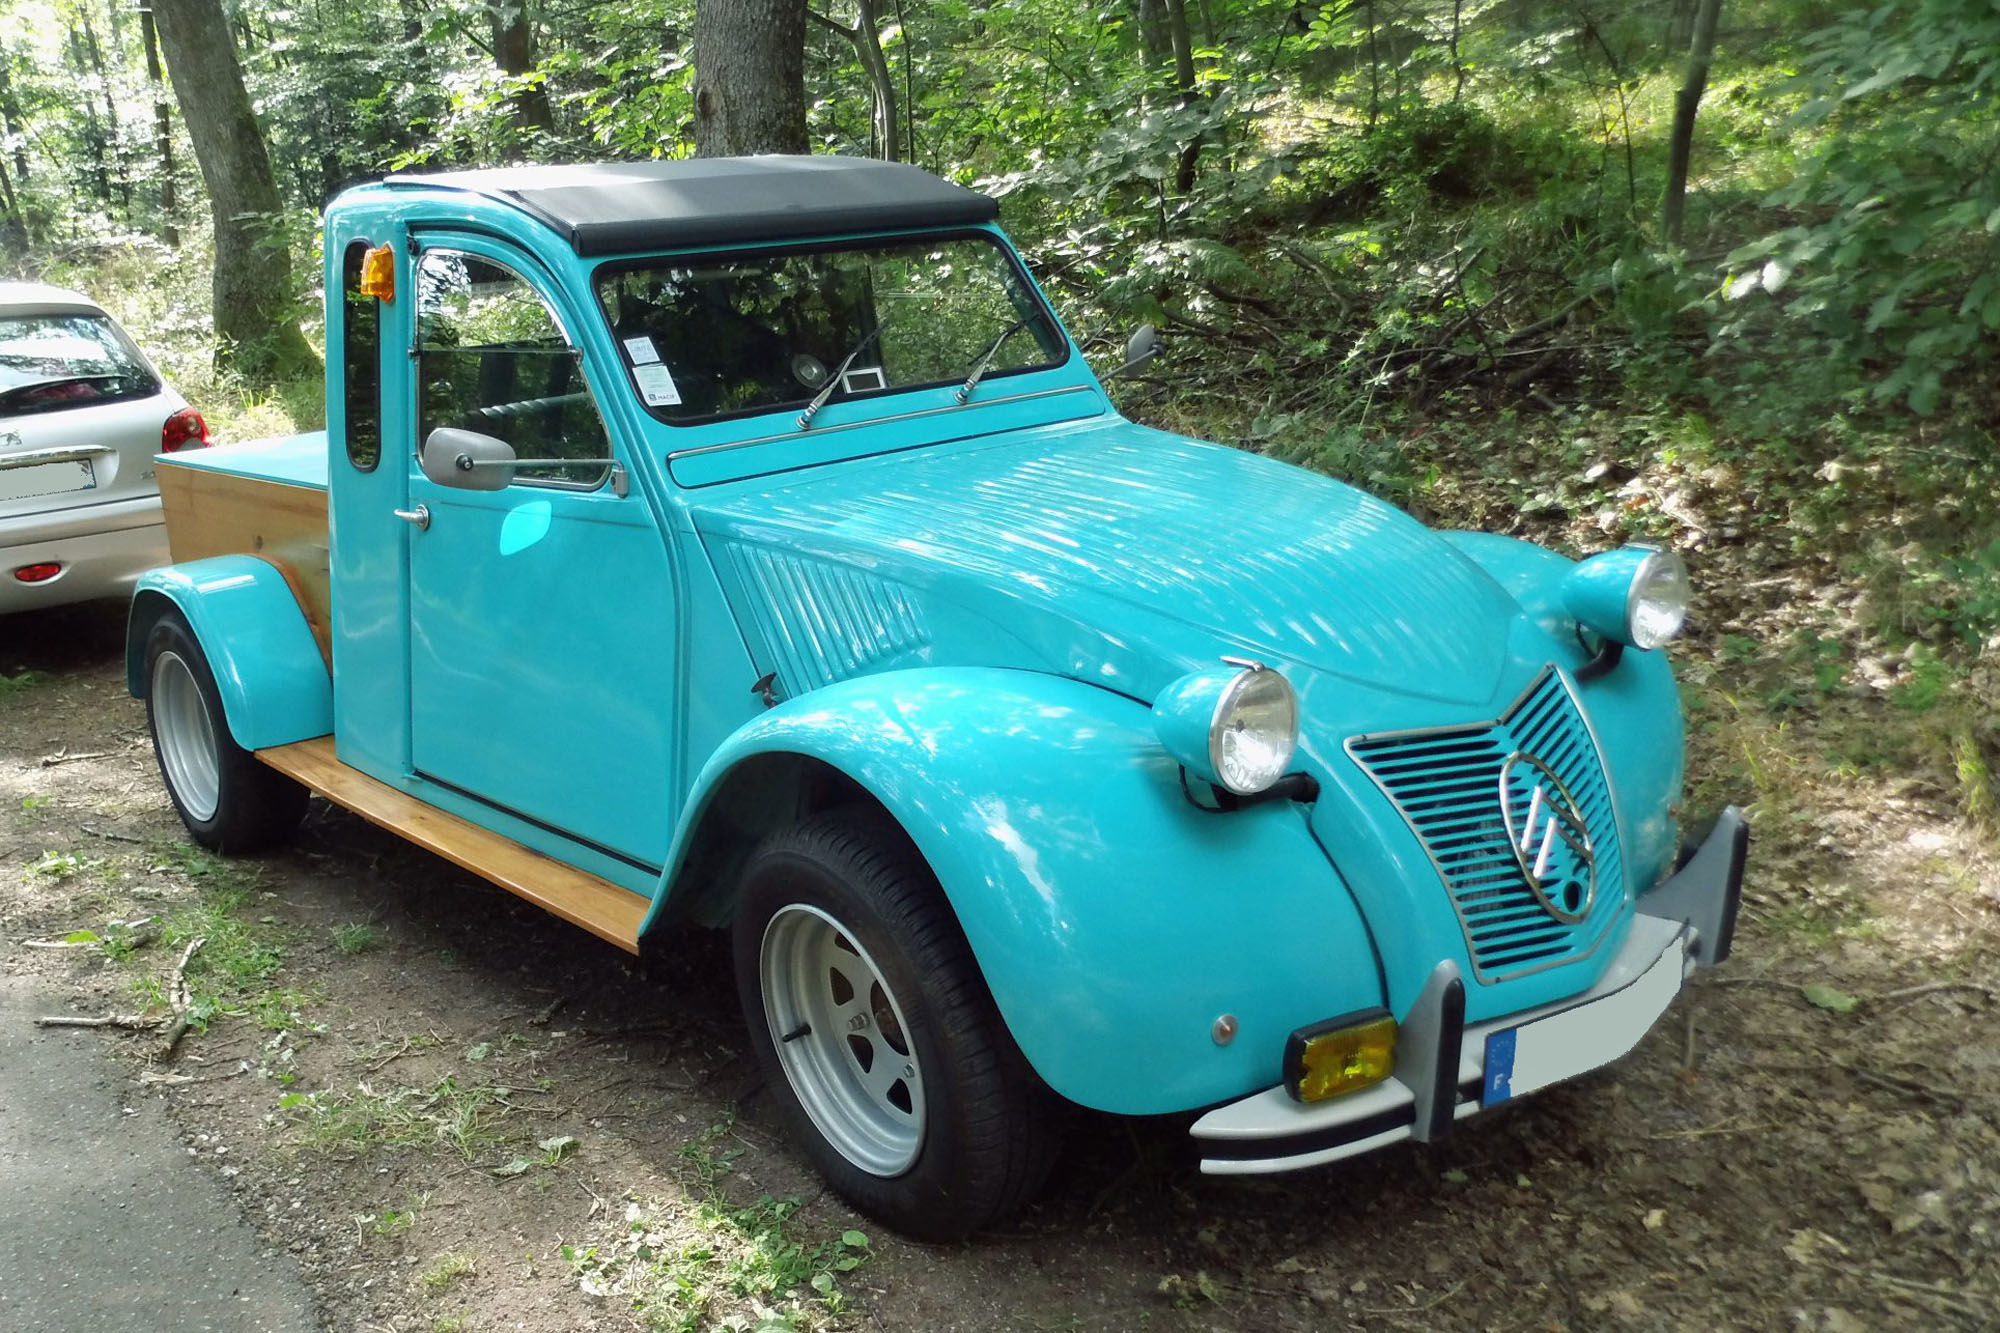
128;156;1748;1237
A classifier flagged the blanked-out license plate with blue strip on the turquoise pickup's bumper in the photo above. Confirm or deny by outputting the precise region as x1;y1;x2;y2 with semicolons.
1480;935;1686;1107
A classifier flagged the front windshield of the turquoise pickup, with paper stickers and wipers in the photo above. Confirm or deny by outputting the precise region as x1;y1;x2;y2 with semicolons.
598;234;1068;424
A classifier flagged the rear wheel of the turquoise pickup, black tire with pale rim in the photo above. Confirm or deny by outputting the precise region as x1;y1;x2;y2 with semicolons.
146;610;308;853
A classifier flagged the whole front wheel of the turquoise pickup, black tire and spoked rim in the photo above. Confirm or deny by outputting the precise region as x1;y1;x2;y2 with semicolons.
734;809;1058;1241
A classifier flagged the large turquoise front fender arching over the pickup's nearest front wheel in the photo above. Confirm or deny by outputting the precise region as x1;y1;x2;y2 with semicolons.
648;669;1382;1115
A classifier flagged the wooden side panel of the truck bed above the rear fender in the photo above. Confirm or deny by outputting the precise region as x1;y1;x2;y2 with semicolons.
158;458;334;669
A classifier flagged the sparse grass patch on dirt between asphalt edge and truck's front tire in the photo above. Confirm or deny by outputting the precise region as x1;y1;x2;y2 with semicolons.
278;1075;512;1161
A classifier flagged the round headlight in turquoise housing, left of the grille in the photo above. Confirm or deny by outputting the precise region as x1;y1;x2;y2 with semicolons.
1152;664;1298;797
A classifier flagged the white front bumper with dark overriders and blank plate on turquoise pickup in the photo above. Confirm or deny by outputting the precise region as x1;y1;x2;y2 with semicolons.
1188;807;1750;1175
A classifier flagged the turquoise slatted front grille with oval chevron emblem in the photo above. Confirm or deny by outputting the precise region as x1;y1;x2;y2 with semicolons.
1348;667;1624;983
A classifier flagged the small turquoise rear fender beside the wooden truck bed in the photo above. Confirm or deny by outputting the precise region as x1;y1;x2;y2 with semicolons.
126;554;334;751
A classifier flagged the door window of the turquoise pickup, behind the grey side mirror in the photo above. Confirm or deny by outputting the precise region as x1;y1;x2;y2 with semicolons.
416;250;612;488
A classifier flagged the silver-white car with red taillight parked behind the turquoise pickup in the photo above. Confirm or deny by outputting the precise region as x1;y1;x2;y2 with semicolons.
0;282;208;614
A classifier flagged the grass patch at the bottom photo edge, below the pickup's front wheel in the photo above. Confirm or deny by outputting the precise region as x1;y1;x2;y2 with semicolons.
562;1123;872;1333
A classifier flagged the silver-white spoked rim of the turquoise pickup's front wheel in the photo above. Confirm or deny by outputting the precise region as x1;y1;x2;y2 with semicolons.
758;903;924;1177
